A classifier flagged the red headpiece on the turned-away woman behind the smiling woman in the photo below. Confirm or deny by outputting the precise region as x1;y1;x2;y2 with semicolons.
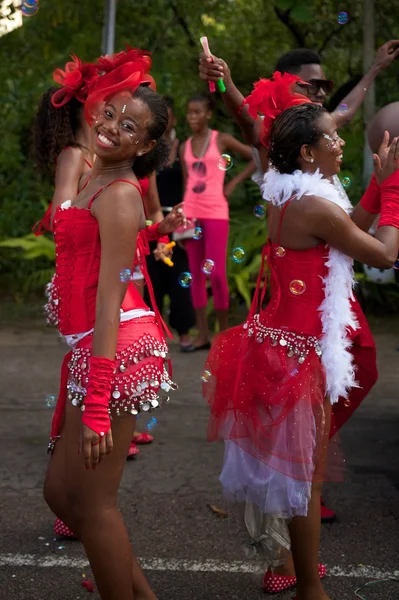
51;54;98;108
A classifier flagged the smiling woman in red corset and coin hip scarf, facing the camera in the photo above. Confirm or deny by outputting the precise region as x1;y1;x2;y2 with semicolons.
40;53;184;600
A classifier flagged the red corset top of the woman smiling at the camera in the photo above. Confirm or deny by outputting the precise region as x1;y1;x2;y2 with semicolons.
53;186;149;335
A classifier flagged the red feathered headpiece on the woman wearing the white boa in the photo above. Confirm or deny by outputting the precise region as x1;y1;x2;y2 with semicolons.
244;71;311;146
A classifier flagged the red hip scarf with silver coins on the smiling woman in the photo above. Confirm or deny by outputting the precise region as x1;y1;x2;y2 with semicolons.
67;334;177;416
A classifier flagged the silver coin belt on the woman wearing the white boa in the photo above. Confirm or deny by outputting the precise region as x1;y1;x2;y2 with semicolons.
243;314;322;364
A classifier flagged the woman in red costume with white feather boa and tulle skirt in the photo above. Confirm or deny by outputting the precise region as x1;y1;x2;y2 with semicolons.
203;73;399;600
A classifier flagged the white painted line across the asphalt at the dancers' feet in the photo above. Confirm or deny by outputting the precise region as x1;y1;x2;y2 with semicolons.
0;554;399;580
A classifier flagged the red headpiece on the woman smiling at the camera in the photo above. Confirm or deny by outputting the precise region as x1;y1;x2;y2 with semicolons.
85;48;156;125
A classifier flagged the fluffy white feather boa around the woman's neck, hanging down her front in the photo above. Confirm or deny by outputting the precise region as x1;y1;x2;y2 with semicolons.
261;169;358;404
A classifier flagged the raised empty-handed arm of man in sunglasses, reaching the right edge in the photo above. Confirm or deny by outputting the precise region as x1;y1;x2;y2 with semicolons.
332;40;399;128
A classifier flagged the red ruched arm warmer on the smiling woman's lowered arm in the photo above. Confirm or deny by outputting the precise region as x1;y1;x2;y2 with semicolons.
82;356;115;436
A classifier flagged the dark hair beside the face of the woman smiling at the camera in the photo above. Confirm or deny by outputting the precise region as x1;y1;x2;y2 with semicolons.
133;85;169;179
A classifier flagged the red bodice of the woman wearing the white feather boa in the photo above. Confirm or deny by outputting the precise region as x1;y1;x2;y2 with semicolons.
261;241;328;337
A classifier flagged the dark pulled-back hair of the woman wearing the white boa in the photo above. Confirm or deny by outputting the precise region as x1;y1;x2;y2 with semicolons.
268;103;327;173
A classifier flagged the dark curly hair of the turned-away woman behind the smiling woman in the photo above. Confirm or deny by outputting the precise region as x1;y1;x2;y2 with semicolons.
32;87;83;177
